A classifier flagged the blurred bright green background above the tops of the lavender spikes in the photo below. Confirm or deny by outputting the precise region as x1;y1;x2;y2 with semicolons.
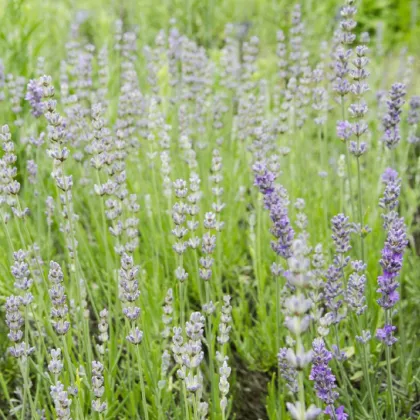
0;0;420;76
